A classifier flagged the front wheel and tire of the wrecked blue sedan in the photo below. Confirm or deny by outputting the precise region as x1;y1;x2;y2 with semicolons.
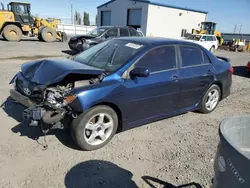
70;106;118;151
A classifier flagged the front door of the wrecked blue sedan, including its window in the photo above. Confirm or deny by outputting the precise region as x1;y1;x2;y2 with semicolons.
123;46;180;124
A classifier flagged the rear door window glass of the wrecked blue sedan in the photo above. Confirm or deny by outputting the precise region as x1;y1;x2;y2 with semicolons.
180;46;205;67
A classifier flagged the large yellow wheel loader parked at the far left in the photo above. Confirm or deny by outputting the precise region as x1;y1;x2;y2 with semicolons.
0;2;67;42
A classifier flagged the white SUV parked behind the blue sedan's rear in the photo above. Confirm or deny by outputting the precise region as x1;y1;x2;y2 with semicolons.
185;34;219;53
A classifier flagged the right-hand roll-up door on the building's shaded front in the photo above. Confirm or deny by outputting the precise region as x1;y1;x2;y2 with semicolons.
127;9;142;27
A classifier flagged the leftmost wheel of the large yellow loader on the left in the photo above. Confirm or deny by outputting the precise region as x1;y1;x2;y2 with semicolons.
3;25;22;42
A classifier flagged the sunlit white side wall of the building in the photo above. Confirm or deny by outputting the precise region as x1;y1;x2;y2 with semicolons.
146;5;207;38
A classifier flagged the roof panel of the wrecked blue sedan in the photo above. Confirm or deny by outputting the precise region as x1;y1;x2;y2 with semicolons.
116;37;203;46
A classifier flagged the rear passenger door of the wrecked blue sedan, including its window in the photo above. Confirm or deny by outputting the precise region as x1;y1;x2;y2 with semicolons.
179;45;215;109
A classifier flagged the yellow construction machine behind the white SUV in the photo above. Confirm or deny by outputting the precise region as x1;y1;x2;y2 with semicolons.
192;22;224;46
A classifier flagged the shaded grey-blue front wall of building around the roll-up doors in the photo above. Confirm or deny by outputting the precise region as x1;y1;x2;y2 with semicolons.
97;0;149;34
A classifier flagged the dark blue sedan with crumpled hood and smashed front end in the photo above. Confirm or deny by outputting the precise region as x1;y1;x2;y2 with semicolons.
10;37;233;150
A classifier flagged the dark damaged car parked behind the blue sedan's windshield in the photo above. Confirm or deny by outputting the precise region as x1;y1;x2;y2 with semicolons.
69;26;144;52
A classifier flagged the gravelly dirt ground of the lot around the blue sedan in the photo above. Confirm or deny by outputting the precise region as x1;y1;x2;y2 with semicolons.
0;40;250;188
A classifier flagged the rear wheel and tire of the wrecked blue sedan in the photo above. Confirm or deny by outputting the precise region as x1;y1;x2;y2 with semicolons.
199;84;221;114
